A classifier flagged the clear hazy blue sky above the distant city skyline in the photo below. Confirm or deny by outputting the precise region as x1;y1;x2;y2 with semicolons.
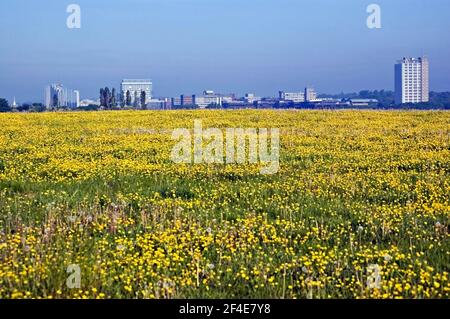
0;0;450;103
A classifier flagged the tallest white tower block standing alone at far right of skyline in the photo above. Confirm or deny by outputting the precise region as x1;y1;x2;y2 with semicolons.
395;57;430;104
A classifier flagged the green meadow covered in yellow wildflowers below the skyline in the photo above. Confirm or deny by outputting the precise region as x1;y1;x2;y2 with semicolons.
0;110;450;298
